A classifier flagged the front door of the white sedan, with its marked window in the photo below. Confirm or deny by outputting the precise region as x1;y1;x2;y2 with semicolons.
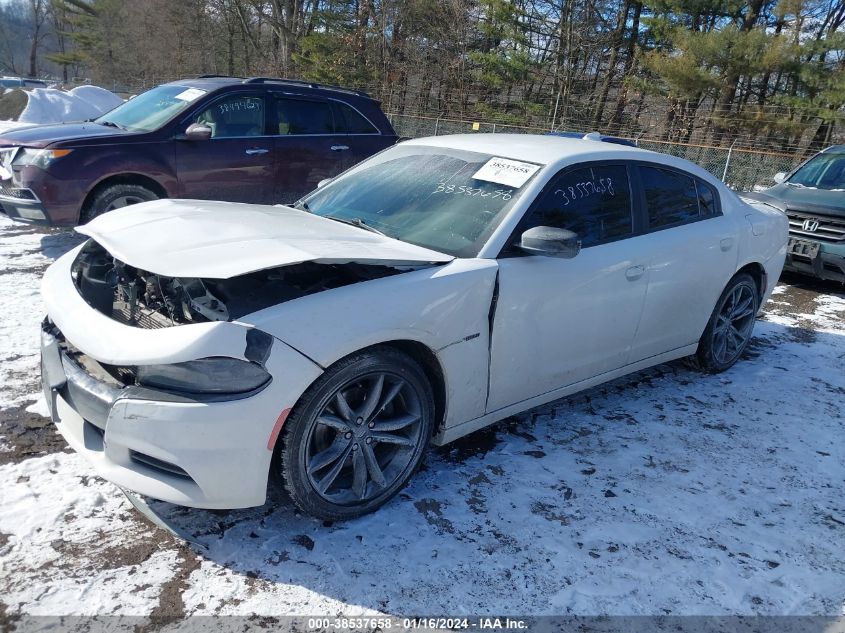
487;163;649;412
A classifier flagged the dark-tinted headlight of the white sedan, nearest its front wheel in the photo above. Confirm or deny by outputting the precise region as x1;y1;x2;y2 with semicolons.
136;356;270;393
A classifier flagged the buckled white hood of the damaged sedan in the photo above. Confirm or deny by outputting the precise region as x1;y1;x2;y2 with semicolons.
76;200;453;279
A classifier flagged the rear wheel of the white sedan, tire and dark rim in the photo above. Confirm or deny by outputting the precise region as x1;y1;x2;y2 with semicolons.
689;273;760;374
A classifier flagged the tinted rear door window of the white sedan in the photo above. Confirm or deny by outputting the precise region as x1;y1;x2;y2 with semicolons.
640;166;704;229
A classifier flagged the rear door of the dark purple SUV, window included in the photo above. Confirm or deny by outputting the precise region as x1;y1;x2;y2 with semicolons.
271;94;350;204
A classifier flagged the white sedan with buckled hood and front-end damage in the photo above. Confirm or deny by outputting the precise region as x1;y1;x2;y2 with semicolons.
42;134;787;519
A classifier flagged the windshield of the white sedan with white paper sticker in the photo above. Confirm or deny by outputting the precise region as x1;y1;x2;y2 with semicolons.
296;144;540;257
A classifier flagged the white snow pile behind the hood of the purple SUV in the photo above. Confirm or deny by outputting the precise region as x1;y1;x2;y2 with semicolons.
18;86;123;124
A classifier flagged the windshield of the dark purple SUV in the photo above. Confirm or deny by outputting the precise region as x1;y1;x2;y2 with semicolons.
95;86;205;132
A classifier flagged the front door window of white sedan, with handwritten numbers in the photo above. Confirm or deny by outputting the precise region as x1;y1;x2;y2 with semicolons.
520;165;634;248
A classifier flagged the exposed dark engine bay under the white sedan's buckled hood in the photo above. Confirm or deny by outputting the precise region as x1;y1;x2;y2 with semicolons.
71;240;413;329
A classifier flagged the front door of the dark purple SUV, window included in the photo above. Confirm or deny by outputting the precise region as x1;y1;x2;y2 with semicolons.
175;92;274;203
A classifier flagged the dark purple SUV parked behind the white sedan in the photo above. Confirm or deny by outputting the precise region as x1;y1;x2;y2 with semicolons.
0;76;397;226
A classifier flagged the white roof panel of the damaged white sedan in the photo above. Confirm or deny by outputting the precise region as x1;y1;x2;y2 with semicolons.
405;134;654;165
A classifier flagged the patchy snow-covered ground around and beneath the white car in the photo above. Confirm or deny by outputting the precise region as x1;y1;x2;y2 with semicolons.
0;217;845;616
